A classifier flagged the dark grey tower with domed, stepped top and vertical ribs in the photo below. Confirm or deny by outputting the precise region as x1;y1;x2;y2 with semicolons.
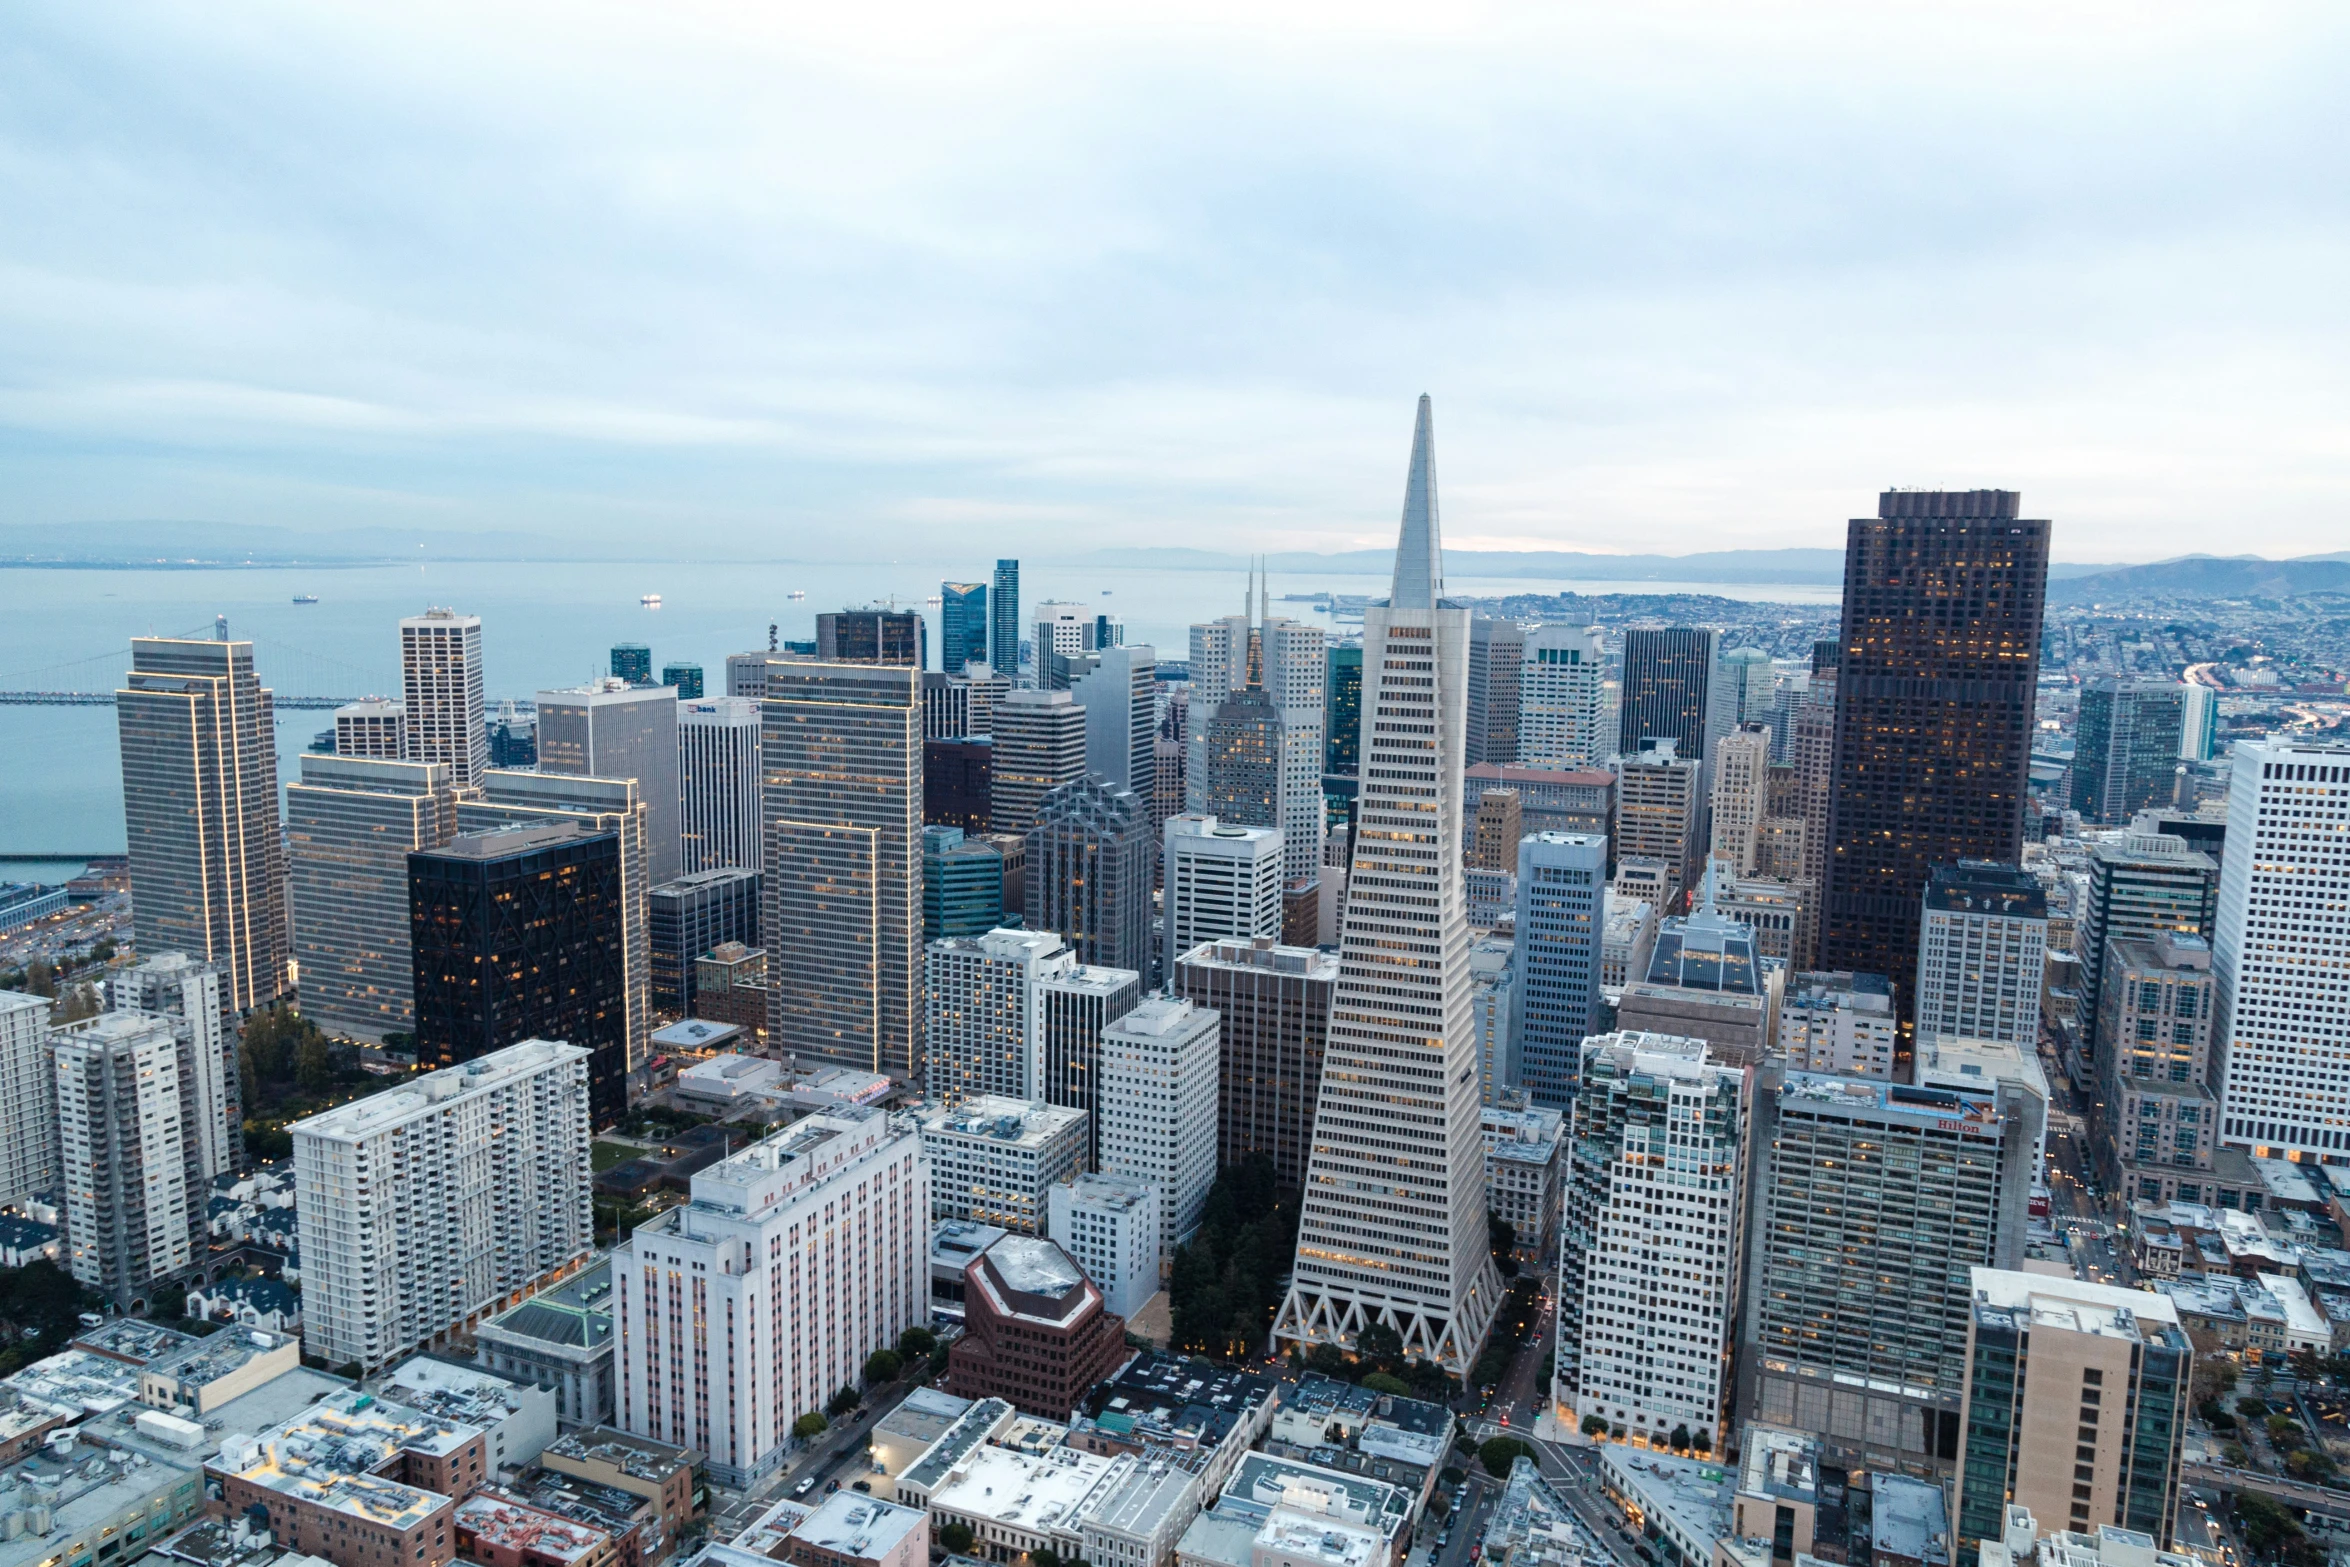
1027;775;1156;975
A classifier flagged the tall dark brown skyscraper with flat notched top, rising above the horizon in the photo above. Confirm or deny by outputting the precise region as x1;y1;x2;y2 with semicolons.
1819;489;2049;1024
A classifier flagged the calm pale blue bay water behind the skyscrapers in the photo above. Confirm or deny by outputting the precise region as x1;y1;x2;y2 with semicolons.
0;559;1838;864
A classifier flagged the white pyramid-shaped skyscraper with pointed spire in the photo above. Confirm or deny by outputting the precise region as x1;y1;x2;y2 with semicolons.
1274;397;1502;1372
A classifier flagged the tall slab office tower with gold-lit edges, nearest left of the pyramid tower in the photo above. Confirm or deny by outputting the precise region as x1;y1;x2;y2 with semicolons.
761;663;921;1081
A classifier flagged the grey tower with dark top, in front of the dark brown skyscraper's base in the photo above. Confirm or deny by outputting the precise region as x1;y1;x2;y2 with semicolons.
1911;860;2049;1050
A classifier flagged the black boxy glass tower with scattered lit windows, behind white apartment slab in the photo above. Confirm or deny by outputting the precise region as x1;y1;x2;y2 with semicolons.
409;822;627;1125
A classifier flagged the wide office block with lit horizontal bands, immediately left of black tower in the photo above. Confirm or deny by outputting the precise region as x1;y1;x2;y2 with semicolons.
287;754;456;1041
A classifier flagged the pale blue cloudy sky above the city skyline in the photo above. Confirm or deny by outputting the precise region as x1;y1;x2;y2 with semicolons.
0;0;2350;561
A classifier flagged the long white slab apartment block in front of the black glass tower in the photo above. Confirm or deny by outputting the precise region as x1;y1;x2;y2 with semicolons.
289;1038;596;1370
